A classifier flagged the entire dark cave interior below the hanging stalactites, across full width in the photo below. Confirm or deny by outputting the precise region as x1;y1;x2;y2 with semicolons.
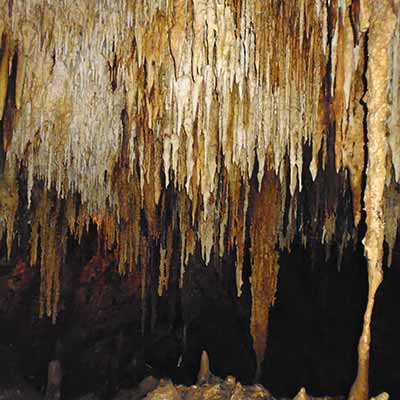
0;217;400;399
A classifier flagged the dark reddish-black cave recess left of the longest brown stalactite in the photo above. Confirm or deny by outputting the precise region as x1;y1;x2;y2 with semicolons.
0;226;255;399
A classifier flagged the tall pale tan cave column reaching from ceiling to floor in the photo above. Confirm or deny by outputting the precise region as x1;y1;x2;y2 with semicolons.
349;0;396;400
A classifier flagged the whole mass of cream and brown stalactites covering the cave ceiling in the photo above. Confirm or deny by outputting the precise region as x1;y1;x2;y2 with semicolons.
0;0;400;396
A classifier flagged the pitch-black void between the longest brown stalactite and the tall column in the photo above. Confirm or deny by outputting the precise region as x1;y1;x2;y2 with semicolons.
261;236;368;396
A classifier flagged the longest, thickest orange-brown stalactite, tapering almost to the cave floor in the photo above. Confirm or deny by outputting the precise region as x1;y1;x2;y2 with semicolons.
250;170;281;374
